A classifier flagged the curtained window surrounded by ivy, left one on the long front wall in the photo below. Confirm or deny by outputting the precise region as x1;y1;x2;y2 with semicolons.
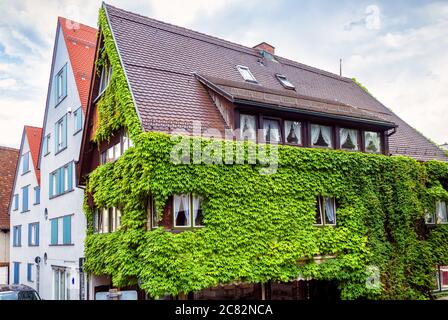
173;194;204;228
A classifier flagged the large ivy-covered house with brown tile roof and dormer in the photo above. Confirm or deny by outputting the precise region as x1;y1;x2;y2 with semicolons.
78;4;448;299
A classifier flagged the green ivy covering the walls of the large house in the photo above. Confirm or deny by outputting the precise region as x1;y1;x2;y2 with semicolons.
85;6;448;299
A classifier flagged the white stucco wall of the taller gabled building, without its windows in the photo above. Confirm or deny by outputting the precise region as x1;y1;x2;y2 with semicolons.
40;24;86;299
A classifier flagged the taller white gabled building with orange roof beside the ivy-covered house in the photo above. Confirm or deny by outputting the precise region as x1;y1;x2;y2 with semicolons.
30;17;97;300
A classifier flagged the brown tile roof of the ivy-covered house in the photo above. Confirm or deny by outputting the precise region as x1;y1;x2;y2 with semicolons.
104;4;448;161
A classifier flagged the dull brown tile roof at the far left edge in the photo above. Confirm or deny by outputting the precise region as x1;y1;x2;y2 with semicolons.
0;146;19;230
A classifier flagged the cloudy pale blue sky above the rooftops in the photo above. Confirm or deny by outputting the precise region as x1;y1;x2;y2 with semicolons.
0;0;448;147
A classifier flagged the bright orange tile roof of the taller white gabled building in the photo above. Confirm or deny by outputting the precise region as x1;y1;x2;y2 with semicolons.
58;17;97;114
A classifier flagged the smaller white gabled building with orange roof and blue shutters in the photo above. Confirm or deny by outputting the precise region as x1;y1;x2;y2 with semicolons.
9;126;42;289
